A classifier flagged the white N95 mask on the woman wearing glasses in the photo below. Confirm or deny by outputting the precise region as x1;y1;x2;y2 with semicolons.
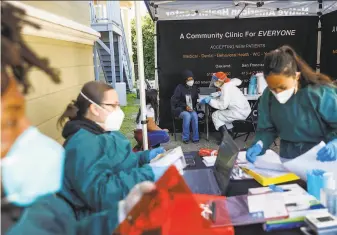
80;92;125;131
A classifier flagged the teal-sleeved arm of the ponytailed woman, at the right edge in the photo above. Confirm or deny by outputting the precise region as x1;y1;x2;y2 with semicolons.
310;86;337;142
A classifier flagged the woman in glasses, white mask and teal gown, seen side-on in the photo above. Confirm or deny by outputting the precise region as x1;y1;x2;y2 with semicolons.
59;81;166;219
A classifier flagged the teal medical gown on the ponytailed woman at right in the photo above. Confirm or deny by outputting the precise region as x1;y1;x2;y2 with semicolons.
254;85;337;158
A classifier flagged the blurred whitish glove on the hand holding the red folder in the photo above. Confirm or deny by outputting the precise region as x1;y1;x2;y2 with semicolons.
118;181;156;223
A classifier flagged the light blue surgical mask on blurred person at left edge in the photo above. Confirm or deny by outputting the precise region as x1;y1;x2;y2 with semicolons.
1;127;65;206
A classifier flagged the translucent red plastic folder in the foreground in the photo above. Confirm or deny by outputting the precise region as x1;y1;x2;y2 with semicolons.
113;166;234;235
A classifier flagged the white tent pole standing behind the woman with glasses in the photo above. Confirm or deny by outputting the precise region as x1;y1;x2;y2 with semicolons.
134;1;148;150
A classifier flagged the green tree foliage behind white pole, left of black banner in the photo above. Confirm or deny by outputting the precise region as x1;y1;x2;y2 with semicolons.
131;15;155;80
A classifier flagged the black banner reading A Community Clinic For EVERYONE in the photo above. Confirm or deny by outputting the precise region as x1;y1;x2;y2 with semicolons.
157;16;317;128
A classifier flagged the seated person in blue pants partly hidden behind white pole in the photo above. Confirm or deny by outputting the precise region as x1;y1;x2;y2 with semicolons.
135;89;170;148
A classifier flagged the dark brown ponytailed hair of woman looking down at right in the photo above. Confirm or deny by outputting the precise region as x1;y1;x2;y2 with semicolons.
263;46;334;87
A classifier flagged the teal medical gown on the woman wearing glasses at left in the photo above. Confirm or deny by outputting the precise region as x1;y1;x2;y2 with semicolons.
60;129;154;219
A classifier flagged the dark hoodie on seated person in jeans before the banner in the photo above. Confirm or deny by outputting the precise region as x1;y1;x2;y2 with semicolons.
171;70;198;117
